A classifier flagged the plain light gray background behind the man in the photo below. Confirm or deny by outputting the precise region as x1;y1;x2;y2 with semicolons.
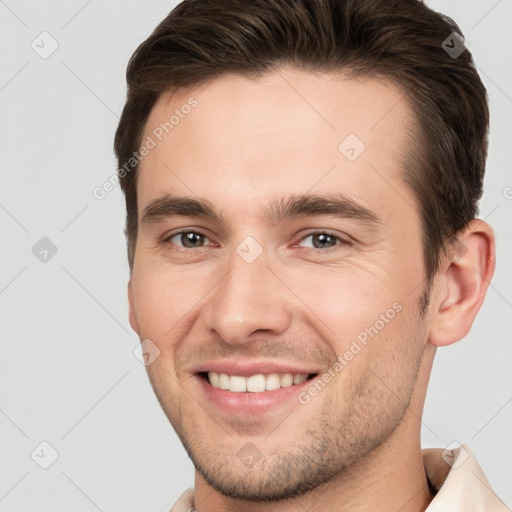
0;0;512;512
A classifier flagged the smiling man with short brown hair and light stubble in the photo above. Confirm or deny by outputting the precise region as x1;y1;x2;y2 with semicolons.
115;0;507;512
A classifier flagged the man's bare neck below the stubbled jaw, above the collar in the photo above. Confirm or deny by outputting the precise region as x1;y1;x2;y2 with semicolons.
195;413;433;512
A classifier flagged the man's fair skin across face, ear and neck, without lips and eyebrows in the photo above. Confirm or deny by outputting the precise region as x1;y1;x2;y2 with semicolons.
128;68;494;512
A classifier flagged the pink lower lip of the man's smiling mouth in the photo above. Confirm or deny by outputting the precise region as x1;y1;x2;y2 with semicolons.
197;375;313;416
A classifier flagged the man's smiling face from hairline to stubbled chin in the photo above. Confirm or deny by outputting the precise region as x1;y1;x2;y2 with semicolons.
130;70;428;500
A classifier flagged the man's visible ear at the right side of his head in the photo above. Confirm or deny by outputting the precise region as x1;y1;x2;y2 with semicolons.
429;219;495;347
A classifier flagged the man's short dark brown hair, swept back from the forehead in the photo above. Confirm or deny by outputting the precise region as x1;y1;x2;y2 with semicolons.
114;0;489;282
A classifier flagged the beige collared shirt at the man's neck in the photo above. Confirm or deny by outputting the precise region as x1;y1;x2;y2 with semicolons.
170;445;511;512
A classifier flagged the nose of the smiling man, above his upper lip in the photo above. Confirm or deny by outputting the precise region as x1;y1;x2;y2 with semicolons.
202;247;292;345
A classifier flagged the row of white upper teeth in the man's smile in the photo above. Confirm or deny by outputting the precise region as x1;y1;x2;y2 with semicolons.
208;372;308;393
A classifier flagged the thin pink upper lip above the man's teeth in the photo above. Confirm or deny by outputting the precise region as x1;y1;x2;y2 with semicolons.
193;359;319;377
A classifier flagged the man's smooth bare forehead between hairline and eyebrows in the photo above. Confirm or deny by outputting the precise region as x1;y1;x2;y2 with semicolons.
137;69;413;222
